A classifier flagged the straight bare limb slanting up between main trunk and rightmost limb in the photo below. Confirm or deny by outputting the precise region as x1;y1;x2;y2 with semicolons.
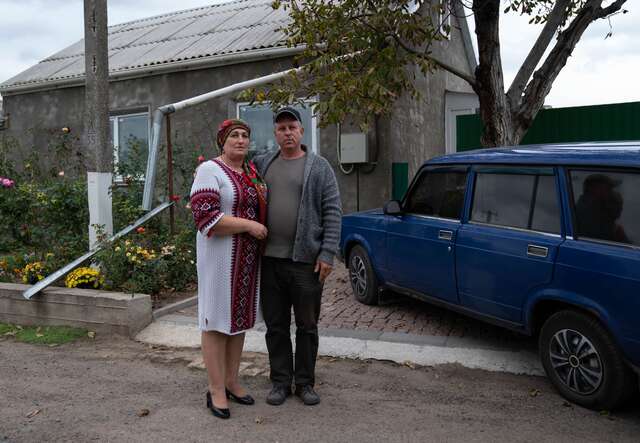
507;0;571;108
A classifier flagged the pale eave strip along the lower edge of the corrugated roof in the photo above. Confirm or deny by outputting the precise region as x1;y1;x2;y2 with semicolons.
0;46;304;97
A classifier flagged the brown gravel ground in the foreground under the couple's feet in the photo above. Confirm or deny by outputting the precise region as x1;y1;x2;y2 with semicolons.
0;337;640;442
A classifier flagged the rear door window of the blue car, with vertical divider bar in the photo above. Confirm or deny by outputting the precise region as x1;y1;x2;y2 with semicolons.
471;172;560;234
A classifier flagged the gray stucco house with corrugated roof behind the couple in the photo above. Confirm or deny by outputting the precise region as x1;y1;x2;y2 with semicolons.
0;0;477;212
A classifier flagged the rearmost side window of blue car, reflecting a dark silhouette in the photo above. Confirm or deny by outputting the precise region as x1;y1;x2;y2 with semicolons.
569;170;640;246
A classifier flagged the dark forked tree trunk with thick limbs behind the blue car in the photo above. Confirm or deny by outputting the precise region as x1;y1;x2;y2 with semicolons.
473;0;627;147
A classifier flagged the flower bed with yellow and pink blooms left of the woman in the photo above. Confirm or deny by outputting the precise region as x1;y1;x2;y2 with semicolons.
0;132;198;297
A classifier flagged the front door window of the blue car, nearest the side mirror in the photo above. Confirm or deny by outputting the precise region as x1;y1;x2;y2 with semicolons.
404;170;467;220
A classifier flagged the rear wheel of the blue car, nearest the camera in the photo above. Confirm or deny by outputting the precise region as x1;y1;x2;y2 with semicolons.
539;310;637;410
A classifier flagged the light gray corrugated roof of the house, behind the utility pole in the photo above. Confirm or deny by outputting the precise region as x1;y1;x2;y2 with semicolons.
0;0;288;91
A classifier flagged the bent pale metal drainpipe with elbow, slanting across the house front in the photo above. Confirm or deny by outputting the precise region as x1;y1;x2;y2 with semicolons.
142;67;302;211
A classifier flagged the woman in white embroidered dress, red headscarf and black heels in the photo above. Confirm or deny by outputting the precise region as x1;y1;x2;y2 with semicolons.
191;120;267;418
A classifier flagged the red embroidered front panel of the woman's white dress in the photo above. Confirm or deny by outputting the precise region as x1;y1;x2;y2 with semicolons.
216;160;260;333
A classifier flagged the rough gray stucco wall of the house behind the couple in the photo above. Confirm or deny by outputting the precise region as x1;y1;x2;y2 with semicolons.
0;14;470;213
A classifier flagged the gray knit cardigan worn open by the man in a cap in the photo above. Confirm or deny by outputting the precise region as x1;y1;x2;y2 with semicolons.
253;146;342;264
